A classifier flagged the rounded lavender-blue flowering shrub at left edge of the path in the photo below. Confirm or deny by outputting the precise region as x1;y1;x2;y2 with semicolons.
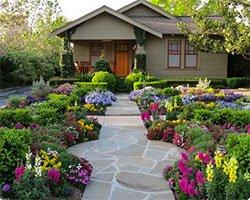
85;91;116;106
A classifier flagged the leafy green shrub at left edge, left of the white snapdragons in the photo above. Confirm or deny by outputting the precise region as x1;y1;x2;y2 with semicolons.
0;128;31;185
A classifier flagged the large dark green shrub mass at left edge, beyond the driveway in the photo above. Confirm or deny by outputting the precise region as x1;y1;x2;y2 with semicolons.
0;51;59;85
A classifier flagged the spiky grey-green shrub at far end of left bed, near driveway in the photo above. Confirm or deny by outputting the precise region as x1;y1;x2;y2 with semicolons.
31;77;52;97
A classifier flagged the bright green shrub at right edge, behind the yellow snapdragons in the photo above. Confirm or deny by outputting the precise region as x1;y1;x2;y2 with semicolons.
226;134;250;173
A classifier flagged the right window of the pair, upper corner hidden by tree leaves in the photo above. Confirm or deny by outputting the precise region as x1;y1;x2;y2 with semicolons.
185;41;198;68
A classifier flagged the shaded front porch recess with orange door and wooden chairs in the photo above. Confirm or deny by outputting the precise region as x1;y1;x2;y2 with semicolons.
72;40;136;77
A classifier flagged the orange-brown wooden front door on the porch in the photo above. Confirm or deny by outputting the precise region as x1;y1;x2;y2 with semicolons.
115;43;130;76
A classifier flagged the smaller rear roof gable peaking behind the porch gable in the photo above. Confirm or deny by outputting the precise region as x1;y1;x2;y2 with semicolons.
118;0;178;20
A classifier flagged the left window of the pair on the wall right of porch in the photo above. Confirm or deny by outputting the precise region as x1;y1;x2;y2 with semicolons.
168;40;181;68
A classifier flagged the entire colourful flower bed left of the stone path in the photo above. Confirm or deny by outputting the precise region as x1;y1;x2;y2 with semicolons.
0;79;115;199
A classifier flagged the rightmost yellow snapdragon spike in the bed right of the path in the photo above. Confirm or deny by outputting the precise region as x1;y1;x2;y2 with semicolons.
223;157;238;183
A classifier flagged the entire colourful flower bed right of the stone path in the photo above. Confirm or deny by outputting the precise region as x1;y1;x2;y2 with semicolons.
129;80;250;200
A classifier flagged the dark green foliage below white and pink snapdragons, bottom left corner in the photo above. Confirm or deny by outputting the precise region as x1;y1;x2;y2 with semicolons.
14;172;50;200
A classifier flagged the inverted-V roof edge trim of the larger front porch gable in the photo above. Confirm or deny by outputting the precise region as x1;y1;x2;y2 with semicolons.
50;6;162;38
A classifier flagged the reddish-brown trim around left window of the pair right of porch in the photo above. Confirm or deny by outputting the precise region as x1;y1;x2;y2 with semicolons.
167;39;182;69
